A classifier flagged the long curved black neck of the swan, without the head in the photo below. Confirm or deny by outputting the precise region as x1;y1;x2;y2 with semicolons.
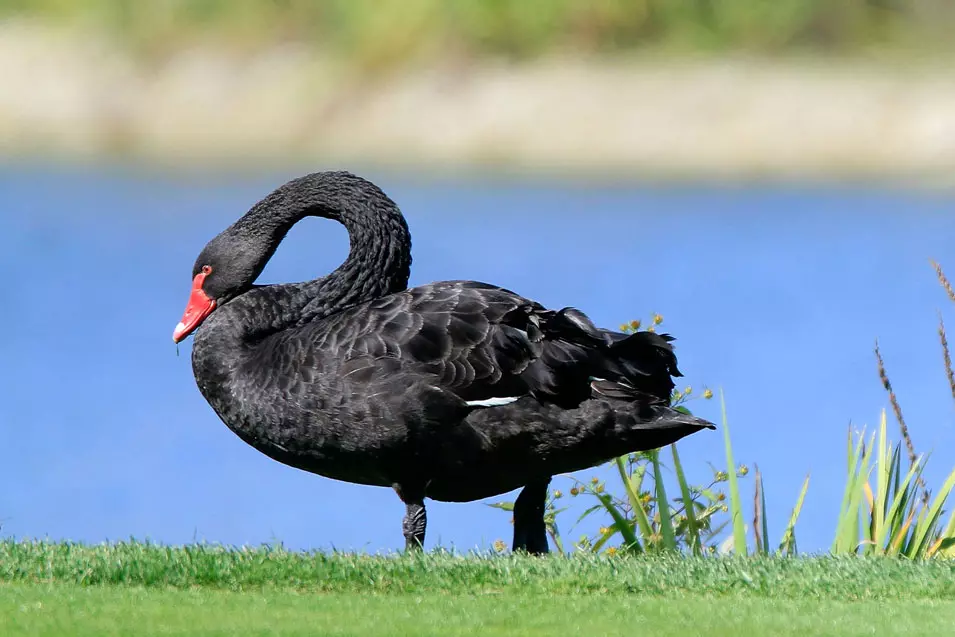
220;172;411;332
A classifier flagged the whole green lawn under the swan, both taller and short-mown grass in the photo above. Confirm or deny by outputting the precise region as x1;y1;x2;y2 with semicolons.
0;541;955;637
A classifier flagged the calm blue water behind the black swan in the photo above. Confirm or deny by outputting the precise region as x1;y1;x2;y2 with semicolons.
0;168;955;551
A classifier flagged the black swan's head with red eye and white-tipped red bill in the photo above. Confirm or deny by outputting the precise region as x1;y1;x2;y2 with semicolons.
172;227;274;343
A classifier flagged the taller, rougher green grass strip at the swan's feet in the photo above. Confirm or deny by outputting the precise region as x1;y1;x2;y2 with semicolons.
0;540;955;601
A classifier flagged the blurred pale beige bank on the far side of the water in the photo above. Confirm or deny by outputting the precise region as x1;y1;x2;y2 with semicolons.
0;22;955;188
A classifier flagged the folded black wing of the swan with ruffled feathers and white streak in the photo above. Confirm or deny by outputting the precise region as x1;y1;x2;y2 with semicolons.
323;281;679;406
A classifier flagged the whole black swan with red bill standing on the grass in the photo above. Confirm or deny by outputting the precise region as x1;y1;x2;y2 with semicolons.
173;172;714;553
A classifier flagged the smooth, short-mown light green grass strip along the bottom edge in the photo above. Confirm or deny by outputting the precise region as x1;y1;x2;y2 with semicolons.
7;584;955;637
